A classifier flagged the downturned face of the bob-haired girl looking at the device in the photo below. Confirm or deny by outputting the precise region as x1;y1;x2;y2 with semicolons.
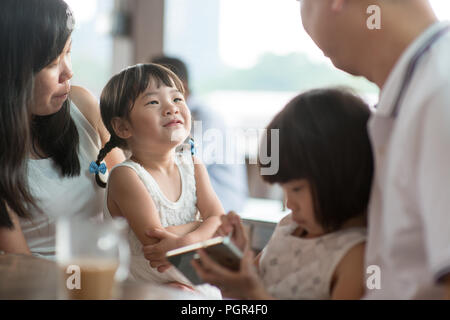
281;179;325;237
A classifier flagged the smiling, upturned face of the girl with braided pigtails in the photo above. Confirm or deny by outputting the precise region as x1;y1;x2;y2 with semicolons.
130;80;191;148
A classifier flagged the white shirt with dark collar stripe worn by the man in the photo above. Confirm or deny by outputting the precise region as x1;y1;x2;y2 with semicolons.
366;22;450;299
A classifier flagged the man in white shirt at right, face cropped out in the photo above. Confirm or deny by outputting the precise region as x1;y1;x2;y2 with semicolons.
301;0;450;299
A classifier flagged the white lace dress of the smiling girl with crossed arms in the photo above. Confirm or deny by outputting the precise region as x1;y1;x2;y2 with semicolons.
103;152;221;299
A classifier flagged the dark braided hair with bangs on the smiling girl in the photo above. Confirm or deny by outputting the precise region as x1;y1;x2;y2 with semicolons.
95;63;184;188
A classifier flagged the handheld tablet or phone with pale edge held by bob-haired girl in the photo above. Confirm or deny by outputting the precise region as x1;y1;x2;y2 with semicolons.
166;236;242;285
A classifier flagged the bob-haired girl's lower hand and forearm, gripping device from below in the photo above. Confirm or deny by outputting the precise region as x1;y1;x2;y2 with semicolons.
192;249;271;299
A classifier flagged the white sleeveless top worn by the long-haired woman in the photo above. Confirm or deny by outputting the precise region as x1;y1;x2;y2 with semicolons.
20;103;105;259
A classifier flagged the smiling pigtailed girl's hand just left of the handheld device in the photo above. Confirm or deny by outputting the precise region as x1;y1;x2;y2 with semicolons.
142;229;180;272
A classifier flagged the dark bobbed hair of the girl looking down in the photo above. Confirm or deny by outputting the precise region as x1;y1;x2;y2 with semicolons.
260;89;373;232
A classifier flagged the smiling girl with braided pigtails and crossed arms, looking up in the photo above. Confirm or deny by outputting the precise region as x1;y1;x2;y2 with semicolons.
91;64;224;293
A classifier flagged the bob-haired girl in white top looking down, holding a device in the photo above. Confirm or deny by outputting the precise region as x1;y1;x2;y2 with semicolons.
194;89;373;299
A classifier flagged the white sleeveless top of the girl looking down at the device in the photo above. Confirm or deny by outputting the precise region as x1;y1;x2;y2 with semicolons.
259;214;366;300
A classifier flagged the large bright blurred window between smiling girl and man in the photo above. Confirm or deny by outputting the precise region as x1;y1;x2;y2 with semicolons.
164;0;378;134
